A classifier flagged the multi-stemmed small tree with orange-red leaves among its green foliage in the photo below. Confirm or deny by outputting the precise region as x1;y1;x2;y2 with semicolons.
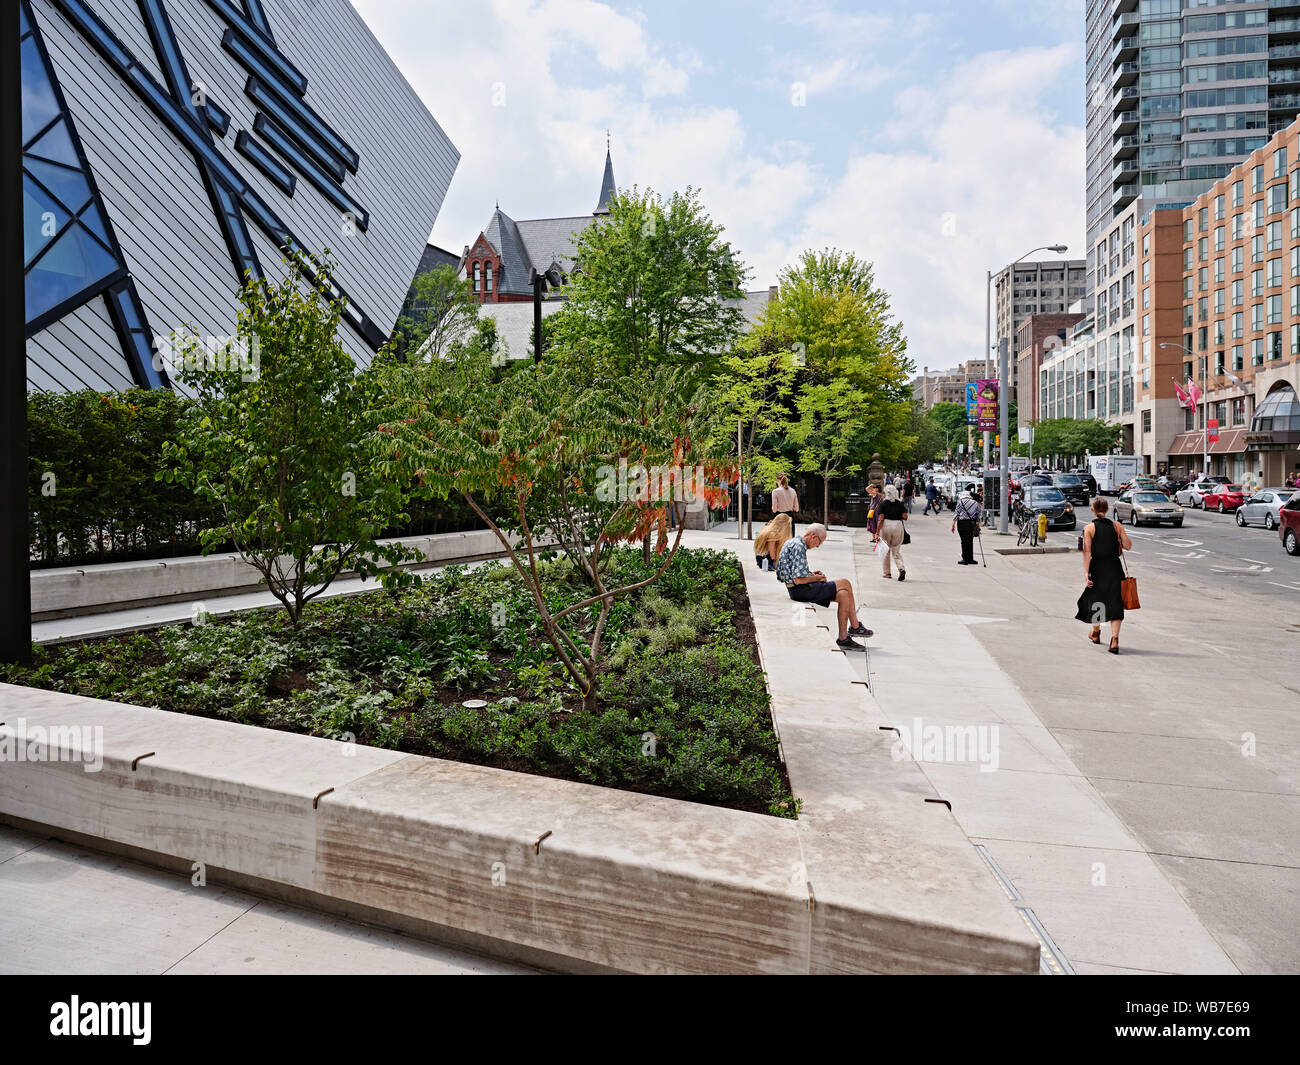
378;347;733;710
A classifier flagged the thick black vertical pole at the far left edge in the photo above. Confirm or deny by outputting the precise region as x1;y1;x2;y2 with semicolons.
0;4;31;662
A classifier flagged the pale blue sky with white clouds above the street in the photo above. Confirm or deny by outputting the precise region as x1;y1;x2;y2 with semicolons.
352;0;1084;371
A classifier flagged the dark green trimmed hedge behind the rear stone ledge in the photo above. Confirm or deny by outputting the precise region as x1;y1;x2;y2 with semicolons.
27;389;482;568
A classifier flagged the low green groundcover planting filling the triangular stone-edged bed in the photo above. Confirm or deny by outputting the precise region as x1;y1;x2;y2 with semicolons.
0;547;800;817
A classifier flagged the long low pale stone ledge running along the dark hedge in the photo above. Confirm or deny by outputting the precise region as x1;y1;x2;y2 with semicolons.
31;529;538;622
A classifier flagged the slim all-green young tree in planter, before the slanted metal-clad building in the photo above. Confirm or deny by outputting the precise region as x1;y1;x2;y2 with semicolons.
157;264;417;628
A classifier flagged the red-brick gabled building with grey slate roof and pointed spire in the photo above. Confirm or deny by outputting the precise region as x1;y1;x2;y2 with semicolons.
460;150;619;303
